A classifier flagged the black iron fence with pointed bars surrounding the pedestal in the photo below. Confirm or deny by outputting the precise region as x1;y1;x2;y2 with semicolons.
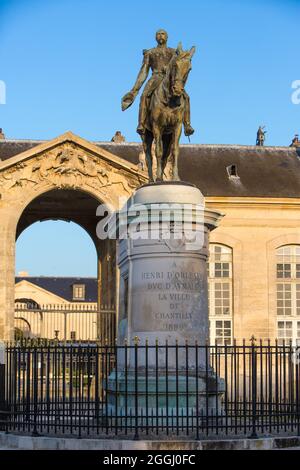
0;341;300;439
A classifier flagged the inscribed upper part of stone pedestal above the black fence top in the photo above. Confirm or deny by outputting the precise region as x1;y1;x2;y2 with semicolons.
117;182;221;354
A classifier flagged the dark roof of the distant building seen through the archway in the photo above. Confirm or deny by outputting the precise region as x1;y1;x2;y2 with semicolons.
15;276;98;303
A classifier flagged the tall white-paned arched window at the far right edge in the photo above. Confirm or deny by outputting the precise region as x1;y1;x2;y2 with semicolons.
276;245;300;343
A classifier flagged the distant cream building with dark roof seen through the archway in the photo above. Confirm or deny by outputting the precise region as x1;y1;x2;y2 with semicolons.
14;275;98;341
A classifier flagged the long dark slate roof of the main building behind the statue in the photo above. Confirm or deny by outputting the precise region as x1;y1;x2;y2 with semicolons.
0;140;300;198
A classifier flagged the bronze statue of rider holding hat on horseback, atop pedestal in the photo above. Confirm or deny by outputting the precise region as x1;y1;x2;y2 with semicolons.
122;30;195;182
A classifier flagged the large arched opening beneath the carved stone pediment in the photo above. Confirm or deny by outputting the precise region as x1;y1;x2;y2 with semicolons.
15;189;116;341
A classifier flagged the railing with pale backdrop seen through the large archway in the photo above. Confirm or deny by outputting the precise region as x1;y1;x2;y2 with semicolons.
15;303;116;343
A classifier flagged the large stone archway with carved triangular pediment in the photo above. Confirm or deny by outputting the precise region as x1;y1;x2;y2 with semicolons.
0;132;145;340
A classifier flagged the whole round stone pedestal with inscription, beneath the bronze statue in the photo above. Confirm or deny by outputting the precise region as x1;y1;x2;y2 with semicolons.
107;182;223;424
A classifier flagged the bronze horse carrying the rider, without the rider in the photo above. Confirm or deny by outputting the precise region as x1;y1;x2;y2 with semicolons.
142;43;195;182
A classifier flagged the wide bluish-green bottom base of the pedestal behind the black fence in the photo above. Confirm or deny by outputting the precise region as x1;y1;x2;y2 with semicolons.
106;370;225;429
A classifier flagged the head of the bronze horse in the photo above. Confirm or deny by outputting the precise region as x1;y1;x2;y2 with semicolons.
170;43;196;97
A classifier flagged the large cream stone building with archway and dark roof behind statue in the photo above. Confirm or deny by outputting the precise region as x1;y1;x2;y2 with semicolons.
0;132;300;343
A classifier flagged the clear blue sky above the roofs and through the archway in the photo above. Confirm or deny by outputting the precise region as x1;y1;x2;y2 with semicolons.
0;0;300;275
